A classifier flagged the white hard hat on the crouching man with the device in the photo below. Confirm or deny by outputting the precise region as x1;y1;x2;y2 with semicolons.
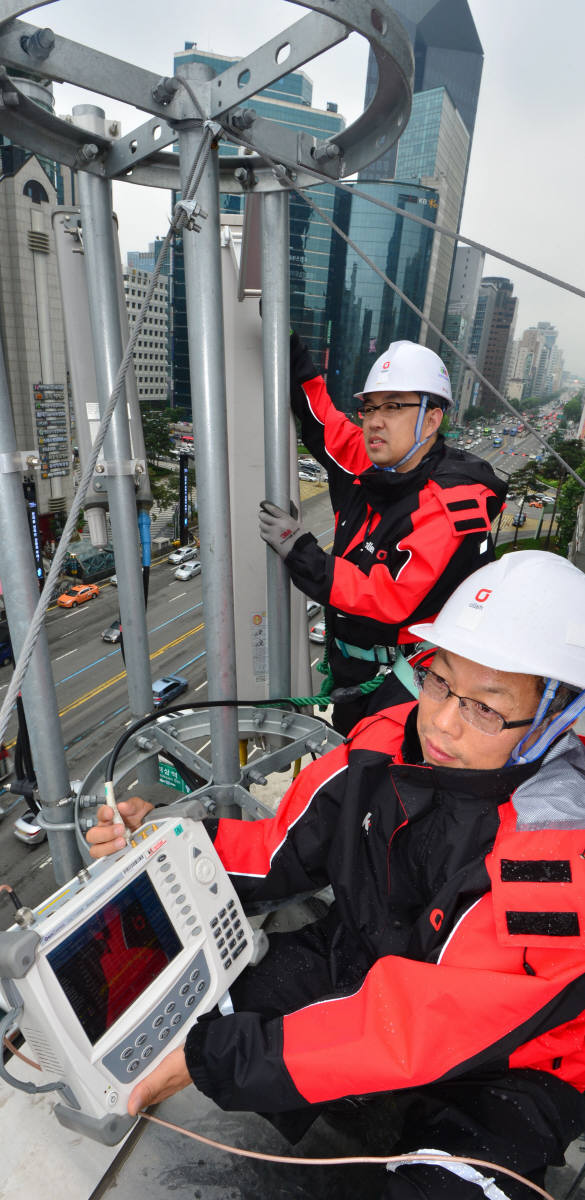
410;550;585;690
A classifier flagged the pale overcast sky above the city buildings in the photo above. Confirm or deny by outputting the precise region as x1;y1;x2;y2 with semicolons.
23;0;585;377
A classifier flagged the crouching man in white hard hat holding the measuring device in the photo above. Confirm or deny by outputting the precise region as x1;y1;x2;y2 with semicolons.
88;551;585;1200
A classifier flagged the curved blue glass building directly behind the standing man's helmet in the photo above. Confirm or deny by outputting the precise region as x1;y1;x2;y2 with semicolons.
323;181;439;409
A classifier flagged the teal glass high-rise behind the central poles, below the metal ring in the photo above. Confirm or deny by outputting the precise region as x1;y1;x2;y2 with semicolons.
171;42;345;410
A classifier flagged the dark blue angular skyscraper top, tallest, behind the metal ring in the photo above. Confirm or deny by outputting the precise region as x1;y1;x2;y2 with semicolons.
364;0;483;179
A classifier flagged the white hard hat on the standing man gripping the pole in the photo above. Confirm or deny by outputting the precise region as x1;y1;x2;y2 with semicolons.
355;342;452;408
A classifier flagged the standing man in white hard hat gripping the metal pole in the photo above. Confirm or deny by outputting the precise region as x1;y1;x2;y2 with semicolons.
260;334;506;733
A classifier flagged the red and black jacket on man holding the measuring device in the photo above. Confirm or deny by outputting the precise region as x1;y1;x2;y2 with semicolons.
186;704;585;1111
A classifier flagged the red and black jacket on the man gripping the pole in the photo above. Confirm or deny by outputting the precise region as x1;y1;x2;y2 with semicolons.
287;376;506;648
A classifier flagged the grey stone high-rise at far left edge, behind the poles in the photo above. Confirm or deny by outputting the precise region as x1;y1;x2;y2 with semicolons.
0;79;73;540
